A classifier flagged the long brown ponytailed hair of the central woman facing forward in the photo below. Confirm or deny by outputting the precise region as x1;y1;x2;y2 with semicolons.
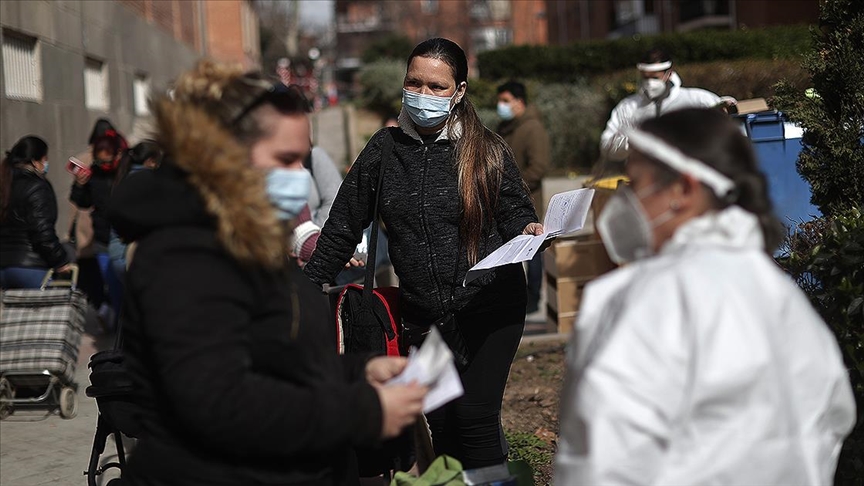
408;37;527;265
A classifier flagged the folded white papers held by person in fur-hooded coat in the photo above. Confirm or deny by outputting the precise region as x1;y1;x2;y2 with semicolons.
387;326;464;413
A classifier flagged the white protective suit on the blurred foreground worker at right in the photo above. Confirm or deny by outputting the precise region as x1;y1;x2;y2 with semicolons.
555;206;855;486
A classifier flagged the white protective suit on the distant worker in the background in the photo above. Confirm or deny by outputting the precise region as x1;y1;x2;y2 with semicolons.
600;72;722;161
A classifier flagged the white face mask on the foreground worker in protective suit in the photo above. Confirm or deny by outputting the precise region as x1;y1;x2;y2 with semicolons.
596;186;674;265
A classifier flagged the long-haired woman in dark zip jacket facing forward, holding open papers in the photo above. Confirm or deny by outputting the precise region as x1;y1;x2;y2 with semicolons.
304;38;543;468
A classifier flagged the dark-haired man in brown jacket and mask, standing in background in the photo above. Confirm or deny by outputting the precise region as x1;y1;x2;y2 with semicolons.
498;81;550;314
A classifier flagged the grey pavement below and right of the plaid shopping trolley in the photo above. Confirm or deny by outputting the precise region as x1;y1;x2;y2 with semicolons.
0;313;116;486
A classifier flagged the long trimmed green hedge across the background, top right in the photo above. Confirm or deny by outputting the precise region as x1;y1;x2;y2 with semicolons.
477;26;811;82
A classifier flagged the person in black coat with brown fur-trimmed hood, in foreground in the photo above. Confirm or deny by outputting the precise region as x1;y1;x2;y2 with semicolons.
110;61;427;486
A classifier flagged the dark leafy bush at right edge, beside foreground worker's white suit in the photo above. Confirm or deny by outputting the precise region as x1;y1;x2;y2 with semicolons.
779;207;864;486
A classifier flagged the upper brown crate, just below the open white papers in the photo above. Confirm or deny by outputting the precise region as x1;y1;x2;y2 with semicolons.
543;239;616;279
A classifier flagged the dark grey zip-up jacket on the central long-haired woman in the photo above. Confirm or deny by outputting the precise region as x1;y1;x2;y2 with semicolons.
304;119;537;322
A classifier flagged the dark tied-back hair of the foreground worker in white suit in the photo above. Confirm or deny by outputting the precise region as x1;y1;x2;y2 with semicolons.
641;108;784;253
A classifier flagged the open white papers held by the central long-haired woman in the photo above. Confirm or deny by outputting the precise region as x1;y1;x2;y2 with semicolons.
462;188;594;285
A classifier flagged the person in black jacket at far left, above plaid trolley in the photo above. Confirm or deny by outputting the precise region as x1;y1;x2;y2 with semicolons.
0;135;70;288
